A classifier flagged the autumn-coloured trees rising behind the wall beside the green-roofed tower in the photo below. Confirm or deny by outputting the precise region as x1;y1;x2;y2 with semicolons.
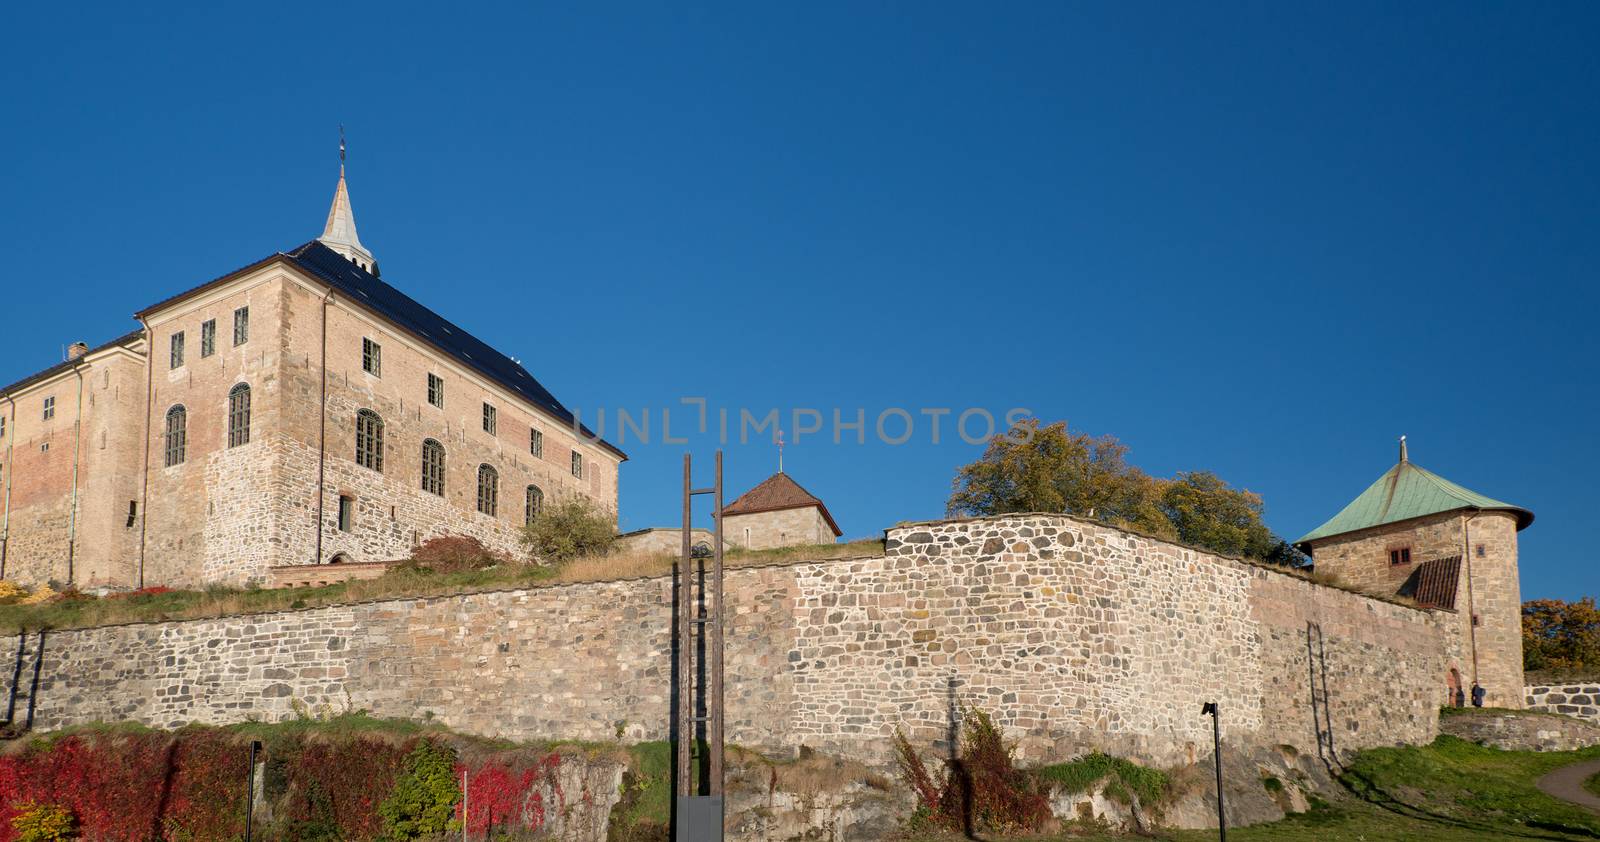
946;418;1306;565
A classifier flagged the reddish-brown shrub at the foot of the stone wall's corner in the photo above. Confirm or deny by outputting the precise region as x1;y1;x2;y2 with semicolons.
894;708;1050;832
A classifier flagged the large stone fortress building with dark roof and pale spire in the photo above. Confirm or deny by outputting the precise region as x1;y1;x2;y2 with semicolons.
0;161;626;587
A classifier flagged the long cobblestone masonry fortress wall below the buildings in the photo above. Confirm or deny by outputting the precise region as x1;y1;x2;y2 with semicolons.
15;515;1446;764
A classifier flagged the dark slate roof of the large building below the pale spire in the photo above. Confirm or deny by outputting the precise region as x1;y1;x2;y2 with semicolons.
139;240;627;459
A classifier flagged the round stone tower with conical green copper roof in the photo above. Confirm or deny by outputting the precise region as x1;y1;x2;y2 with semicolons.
1294;437;1533;708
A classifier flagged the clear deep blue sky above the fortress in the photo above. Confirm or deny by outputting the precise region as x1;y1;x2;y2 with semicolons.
0;3;1600;599
